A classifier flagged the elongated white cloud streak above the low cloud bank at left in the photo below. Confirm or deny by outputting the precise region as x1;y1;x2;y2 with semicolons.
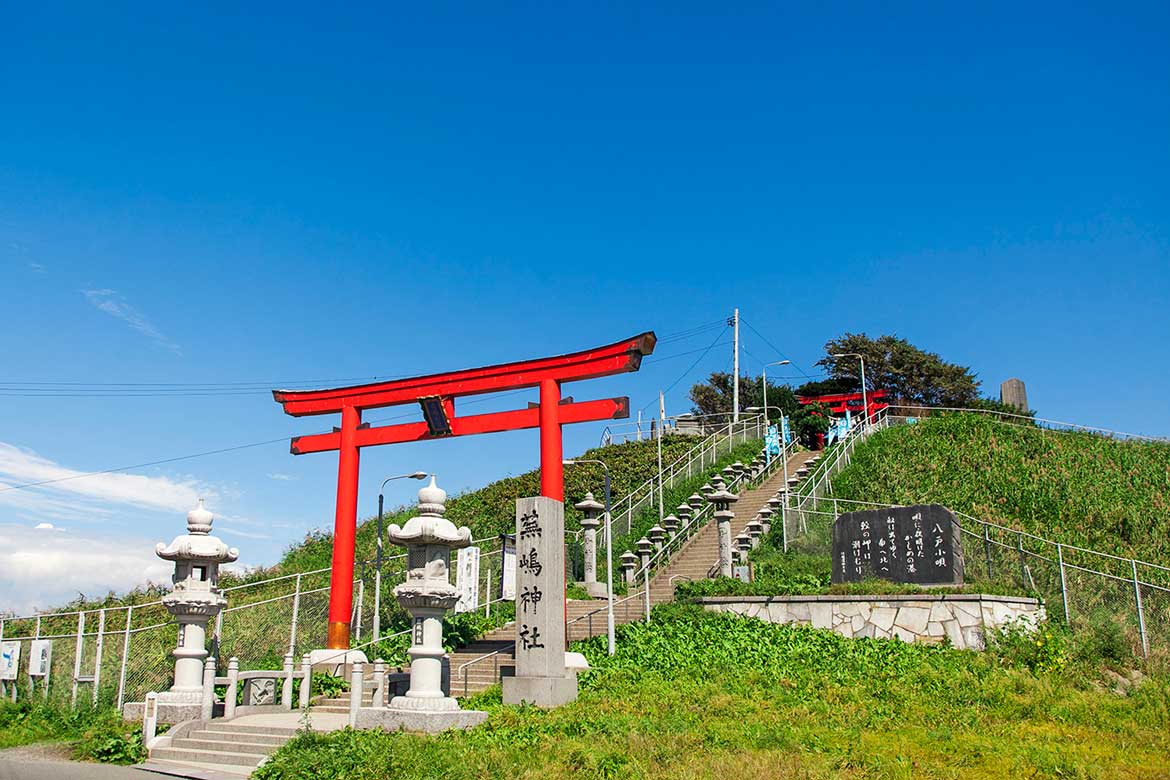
0;442;207;519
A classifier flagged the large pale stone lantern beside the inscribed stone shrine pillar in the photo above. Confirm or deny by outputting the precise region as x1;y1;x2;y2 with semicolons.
376;476;487;731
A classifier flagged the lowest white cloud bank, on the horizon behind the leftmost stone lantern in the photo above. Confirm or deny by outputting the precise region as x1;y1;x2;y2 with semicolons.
0;525;173;614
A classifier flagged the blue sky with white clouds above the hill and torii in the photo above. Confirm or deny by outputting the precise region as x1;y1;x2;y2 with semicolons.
0;4;1170;608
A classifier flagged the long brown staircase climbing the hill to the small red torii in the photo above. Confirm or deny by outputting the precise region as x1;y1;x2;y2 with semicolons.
446;451;817;702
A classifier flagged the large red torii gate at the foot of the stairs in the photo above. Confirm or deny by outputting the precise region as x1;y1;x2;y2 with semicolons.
273;331;656;649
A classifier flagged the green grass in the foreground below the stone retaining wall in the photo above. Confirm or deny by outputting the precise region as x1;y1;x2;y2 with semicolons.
254;606;1170;780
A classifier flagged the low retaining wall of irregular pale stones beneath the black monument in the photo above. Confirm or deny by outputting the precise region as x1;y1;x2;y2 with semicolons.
695;593;1045;650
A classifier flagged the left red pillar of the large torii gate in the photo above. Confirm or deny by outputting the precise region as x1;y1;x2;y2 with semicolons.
325;406;362;650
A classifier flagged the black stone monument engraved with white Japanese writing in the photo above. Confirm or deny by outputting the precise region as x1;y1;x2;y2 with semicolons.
833;504;963;585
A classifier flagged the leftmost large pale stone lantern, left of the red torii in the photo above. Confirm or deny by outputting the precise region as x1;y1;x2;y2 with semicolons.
150;498;240;723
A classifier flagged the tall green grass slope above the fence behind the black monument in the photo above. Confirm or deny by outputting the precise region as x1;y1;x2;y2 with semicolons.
833;414;1170;564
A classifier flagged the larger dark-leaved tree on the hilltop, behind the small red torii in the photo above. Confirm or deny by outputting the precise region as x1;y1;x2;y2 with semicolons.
817;333;979;407
